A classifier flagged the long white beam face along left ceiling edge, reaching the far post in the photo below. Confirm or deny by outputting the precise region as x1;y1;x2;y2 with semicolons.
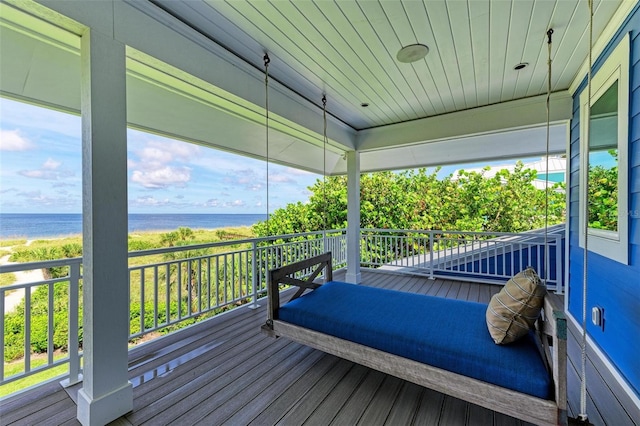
31;0;356;150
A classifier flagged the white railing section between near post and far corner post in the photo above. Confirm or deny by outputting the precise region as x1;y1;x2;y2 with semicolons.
129;230;346;339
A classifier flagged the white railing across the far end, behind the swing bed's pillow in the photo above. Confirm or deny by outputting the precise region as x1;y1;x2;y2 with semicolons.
360;225;564;292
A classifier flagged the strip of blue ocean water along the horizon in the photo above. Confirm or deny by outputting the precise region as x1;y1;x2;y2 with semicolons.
0;213;266;239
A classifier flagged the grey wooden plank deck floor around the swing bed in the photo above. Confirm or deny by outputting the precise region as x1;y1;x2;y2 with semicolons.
0;272;536;426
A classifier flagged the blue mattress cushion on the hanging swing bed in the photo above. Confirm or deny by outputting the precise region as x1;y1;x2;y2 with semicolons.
278;281;552;399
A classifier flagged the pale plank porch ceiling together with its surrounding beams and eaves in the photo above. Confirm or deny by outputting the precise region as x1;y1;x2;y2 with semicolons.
0;0;633;174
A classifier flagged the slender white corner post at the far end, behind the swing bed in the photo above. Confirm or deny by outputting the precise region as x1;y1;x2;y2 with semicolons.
345;151;362;284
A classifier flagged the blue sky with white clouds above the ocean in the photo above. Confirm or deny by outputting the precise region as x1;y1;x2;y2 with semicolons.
0;98;320;214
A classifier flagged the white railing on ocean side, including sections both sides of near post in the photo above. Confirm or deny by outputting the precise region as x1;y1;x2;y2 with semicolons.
0;230;346;389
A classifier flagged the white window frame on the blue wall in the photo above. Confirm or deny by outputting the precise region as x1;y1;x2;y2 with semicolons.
579;34;630;265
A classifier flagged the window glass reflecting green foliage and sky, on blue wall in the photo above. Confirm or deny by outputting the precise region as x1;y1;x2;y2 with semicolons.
588;81;618;231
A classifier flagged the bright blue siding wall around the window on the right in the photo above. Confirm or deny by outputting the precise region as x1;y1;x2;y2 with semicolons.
568;7;640;395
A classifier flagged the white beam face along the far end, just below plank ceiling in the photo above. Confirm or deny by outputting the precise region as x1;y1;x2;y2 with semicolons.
356;91;572;152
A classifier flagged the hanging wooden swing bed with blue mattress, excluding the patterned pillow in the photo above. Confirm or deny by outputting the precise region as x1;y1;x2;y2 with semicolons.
262;253;566;425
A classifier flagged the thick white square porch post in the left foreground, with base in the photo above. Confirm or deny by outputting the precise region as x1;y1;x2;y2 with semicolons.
78;30;133;426
